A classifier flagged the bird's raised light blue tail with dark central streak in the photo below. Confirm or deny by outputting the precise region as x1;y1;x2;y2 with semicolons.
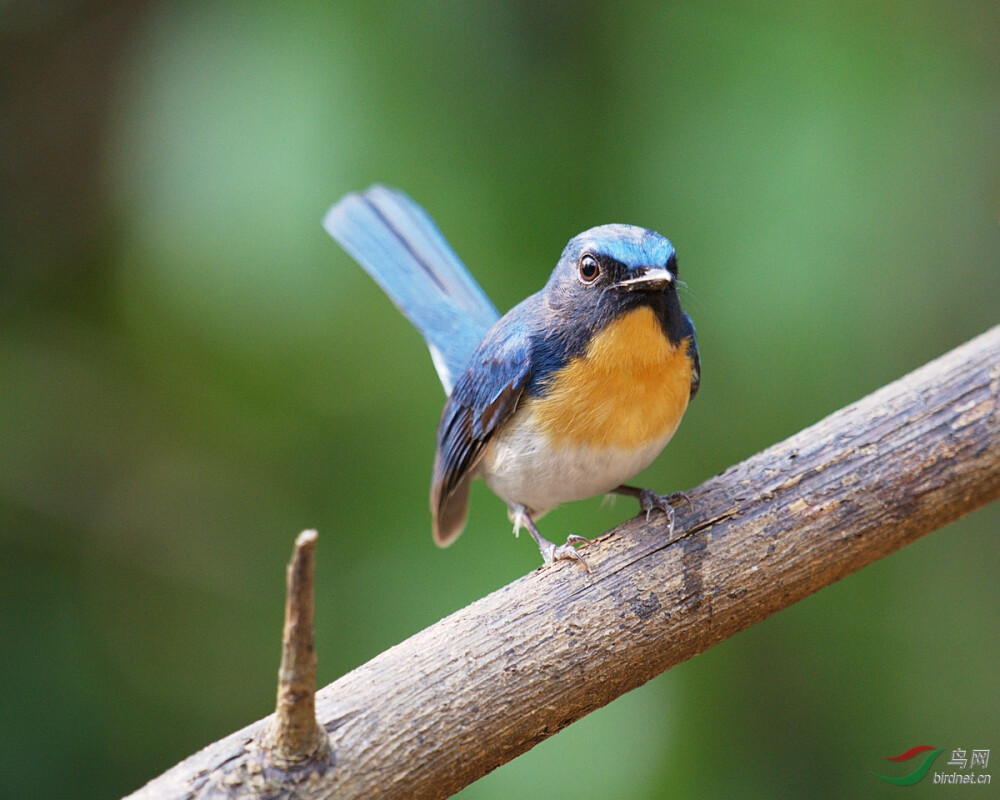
323;185;500;393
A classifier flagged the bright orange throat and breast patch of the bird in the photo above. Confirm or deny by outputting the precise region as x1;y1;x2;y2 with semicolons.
525;306;691;448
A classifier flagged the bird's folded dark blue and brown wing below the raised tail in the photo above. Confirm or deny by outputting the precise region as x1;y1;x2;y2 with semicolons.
431;310;533;547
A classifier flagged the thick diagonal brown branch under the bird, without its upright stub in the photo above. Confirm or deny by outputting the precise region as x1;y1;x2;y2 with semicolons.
125;326;1000;798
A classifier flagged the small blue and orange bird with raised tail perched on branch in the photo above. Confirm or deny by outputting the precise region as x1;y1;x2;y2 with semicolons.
323;186;700;570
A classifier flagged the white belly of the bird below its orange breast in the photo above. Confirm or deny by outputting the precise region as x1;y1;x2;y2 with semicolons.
478;413;679;519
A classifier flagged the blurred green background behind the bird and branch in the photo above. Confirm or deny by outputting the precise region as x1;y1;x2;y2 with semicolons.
0;0;1000;799
